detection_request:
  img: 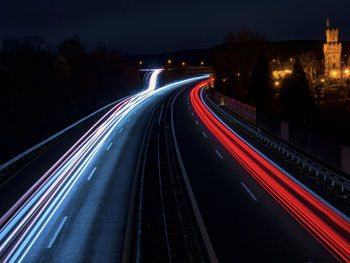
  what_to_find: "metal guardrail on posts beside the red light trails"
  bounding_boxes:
[205,93,350,196]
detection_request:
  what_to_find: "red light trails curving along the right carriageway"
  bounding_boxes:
[191,79,350,262]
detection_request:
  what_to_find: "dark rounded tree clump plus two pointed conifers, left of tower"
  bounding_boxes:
[212,30,315,127]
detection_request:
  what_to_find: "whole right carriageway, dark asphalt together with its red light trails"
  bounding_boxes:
[174,80,350,262]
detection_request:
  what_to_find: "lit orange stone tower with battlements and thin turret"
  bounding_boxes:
[323,19,342,79]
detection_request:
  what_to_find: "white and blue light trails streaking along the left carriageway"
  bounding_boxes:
[0,69,208,262]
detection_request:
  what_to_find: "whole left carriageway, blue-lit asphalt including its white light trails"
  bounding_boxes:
[0,70,205,262]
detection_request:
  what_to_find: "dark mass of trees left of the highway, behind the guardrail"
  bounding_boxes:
[0,38,141,163]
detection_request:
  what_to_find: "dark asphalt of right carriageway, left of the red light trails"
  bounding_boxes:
[174,81,349,262]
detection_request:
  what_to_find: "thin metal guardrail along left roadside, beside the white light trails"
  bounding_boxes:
[0,96,129,172]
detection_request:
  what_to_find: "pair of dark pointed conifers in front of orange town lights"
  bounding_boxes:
[247,55,316,125]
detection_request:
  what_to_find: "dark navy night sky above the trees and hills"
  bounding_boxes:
[0,0,350,54]
